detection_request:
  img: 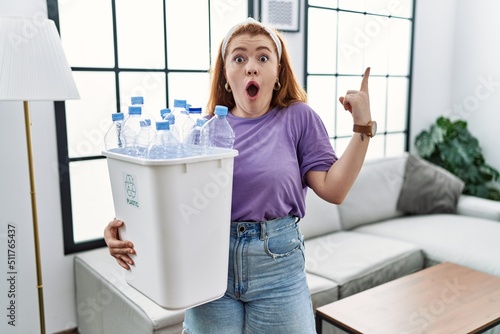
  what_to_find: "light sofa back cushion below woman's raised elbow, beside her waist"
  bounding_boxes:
[300,189,342,239]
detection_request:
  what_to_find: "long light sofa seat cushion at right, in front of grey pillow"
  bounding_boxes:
[356,214,500,276]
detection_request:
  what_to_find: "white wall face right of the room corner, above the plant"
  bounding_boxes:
[451,0,500,175]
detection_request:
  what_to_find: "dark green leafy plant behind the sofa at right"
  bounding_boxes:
[415,116,500,201]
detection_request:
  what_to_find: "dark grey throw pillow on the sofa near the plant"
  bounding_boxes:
[397,154,465,214]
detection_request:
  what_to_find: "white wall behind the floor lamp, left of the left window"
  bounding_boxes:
[0,0,76,334]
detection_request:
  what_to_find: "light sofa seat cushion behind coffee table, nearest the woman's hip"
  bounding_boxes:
[305,231,424,299]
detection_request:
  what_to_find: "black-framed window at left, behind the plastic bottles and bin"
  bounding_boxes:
[47,0,253,254]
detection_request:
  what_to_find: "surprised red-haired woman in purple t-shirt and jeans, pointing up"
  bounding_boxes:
[104,18,375,334]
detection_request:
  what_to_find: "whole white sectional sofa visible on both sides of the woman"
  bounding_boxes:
[74,154,500,334]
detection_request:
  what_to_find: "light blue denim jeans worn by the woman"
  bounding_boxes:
[183,216,316,334]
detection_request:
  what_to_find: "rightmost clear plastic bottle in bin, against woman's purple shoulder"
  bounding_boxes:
[201,106,235,148]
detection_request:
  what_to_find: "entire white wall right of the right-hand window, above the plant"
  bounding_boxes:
[411,0,500,177]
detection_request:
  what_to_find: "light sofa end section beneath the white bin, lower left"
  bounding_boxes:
[74,248,184,334]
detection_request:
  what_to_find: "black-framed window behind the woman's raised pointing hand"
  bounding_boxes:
[305,0,414,159]
